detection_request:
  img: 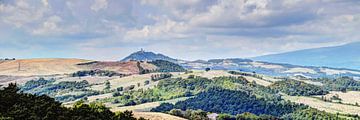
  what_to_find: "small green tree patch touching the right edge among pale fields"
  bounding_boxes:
[311,77,360,92]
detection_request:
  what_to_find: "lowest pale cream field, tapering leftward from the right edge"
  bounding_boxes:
[284,96,360,115]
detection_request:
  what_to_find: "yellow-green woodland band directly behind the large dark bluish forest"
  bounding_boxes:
[102,77,248,106]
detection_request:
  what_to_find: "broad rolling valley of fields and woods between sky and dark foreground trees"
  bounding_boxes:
[0,53,360,120]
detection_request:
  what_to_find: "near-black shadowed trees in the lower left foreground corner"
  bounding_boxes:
[0,84,143,120]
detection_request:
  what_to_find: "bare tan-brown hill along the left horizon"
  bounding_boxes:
[0,58,157,76]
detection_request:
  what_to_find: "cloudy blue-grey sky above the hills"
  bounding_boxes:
[0,0,360,60]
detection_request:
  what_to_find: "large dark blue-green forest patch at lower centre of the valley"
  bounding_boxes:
[153,88,306,116]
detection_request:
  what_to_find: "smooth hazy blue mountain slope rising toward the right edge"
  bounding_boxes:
[252,42,360,70]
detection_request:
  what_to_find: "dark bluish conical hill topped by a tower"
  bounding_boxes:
[121,50,179,63]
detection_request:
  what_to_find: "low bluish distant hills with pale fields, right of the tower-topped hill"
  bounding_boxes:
[181,58,360,78]
